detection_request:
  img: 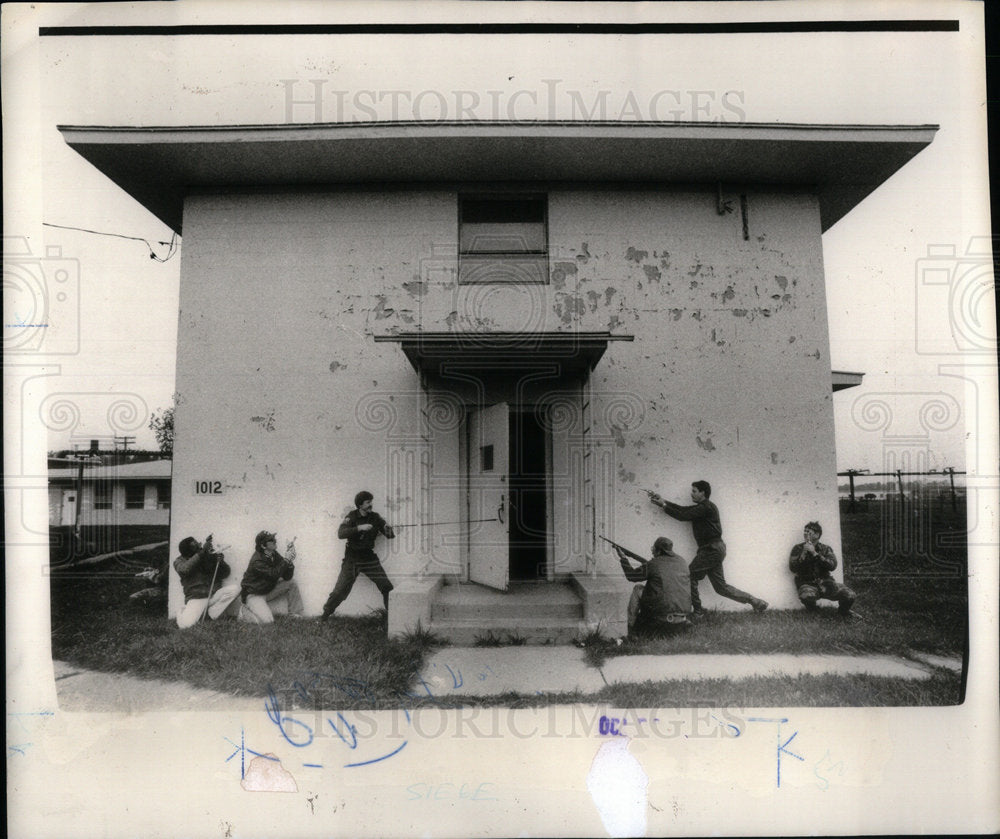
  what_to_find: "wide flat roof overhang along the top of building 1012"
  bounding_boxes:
[59,121,938,233]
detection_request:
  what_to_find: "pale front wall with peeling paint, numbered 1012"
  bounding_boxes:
[171,189,839,613]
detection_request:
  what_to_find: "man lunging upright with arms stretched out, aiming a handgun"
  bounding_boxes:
[649,481,767,617]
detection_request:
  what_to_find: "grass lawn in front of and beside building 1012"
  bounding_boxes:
[51,506,968,708]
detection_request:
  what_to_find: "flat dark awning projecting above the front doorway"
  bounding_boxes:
[375,332,635,375]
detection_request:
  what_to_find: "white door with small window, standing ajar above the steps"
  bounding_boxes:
[469,402,510,591]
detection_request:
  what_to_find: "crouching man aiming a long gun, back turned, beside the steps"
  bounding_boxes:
[615,536,691,635]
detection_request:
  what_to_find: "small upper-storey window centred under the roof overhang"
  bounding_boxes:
[458,196,548,283]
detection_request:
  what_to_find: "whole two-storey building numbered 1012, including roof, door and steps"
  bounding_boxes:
[61,122,936,637]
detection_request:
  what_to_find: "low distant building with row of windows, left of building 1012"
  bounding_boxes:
[48,460,173,527]
